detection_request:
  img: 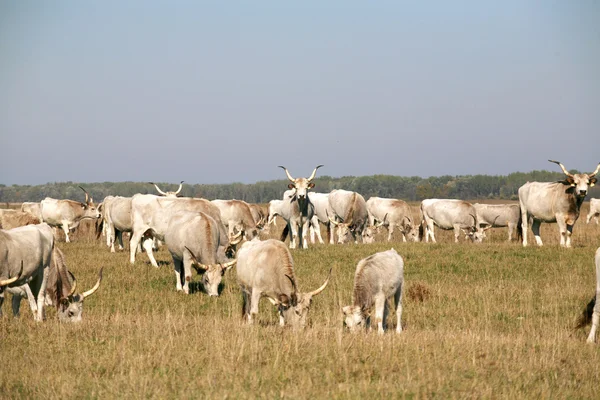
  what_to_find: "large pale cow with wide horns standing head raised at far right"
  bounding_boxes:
[519,160,600,247]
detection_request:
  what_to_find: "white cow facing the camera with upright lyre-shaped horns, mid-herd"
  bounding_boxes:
[279,165,322,249]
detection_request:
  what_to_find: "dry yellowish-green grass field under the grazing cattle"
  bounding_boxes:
[0,204,600,399]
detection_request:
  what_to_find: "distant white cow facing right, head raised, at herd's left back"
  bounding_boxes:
[41,186,100,243]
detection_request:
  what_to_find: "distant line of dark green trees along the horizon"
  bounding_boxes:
[0,171,600,203]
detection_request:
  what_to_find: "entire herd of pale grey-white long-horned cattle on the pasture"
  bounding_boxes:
[0,160,600,341]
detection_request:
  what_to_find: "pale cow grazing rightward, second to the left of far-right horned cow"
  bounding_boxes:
[421,199,485,243]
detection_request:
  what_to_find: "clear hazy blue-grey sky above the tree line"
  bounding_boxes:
[0,0,600,184]
